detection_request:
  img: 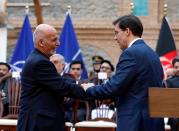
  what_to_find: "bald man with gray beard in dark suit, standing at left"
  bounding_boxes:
[17,24,85,131]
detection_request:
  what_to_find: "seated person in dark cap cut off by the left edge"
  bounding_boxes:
[0,62,11,116]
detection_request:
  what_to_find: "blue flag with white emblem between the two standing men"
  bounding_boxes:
[56,13,87,79]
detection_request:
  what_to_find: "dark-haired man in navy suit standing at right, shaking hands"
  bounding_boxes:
[83,15,164,131]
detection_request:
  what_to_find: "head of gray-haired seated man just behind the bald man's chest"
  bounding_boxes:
[50,54,65,75]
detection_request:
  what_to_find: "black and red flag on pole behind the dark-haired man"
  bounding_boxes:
[156,16,177,79]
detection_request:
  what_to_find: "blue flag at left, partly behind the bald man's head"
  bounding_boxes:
[10,15,34,72]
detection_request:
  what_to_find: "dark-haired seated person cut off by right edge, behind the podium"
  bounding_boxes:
[165,56,179,131]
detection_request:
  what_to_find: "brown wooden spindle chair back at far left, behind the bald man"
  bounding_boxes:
[3,77,21,119]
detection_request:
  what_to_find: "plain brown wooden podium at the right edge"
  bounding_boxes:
[149,87,179,129]
